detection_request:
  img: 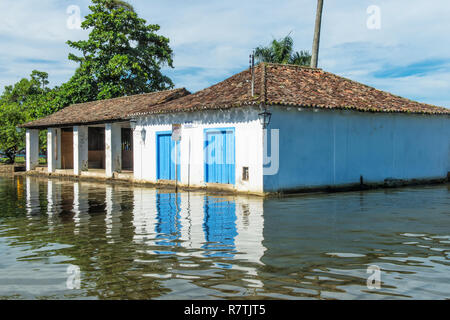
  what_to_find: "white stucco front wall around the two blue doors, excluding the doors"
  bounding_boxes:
[133,108,263,192]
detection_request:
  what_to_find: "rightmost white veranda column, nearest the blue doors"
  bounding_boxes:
[105,123,122,178]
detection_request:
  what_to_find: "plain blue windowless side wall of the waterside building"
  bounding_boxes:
[264,107,450,192]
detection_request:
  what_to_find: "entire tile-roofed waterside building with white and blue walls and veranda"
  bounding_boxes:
[24,64,450,194]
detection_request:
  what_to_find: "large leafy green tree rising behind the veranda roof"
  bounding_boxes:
[65,0,173,101]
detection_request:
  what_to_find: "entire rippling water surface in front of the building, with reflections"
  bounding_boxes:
[0,177,450,299]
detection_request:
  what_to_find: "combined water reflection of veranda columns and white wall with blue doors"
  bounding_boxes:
[26,177,265,263]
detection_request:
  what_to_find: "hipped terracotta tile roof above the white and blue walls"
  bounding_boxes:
[130,63,450,117]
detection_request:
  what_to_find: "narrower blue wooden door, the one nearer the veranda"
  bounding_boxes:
[156,131,180,180]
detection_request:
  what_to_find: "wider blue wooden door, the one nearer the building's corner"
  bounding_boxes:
[205,129,236,184]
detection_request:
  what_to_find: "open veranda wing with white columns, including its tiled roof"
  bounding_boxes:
[21,88,189,178]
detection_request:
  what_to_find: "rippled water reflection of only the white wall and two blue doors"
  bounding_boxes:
[133,188,265,263]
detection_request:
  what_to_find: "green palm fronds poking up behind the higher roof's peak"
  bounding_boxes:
[255,35,311,66]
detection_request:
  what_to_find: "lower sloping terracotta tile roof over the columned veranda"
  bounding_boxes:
[21,88,190,129]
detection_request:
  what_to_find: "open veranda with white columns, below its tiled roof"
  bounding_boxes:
[26,121,133,178]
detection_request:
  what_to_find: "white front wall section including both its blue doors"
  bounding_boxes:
[130,108,263,193]
